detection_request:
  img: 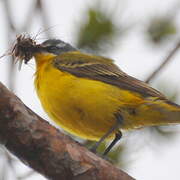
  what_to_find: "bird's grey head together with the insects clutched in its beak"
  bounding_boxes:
[12,35,77,68]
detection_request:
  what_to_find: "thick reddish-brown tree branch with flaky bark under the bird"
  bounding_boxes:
[0,83,133,180]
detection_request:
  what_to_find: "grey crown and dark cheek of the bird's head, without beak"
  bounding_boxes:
[41,39,77,55]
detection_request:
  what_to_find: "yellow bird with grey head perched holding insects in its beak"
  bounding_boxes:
[13,38,180,155]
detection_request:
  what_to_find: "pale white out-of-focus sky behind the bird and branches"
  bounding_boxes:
[0,0,180,180]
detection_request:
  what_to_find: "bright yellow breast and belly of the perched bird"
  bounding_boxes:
[35,61,142,140]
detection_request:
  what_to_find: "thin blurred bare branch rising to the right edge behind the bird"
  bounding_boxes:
[145,41,180,83]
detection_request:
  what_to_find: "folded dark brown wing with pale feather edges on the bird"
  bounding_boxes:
[53,51,166,99]
